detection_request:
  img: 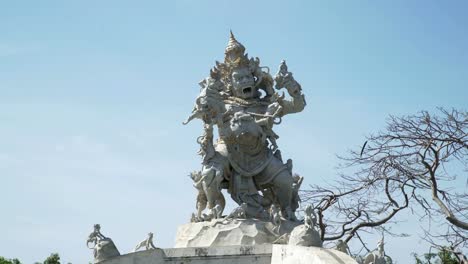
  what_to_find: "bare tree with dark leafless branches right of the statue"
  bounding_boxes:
[302,108,468,254]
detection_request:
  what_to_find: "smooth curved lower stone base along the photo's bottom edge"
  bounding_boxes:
[99,244,357,264]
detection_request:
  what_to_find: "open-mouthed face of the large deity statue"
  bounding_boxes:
[232,68,257,99]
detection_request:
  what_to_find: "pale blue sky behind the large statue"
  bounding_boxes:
[0,0,468,263]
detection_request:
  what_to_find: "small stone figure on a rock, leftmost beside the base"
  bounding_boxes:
[86,224,120,263]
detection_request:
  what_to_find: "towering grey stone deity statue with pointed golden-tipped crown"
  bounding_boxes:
[184,32,306,221]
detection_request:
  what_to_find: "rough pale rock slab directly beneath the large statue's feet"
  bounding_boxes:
[175,219,298,248]
